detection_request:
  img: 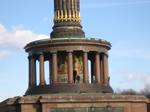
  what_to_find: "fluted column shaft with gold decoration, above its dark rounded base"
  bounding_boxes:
[54,0,80,22]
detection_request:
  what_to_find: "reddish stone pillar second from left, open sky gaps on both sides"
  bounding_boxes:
[39,54,45,85]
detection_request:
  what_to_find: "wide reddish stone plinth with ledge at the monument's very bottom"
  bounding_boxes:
[0,93,149,112]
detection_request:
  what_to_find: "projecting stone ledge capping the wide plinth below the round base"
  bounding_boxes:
[19,93,149,103]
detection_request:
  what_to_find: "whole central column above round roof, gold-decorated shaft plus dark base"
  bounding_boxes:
[50,0,85,38]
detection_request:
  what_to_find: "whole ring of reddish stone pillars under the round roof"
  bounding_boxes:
[28,52,109,87]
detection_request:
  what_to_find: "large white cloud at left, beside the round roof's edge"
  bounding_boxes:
[0,24,49,48]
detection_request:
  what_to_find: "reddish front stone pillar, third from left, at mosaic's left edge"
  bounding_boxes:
[52,52,58,83]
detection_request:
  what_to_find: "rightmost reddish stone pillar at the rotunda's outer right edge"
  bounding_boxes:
[103,54,109,85]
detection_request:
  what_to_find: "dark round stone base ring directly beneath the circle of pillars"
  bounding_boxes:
[25,83,113,95]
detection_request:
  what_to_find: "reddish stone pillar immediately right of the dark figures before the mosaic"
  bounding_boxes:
[83,52,89,83]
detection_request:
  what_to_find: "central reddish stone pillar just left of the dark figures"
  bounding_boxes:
[68,52,73,83]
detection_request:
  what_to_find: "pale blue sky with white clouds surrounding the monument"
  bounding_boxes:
[0,0,150,101]
